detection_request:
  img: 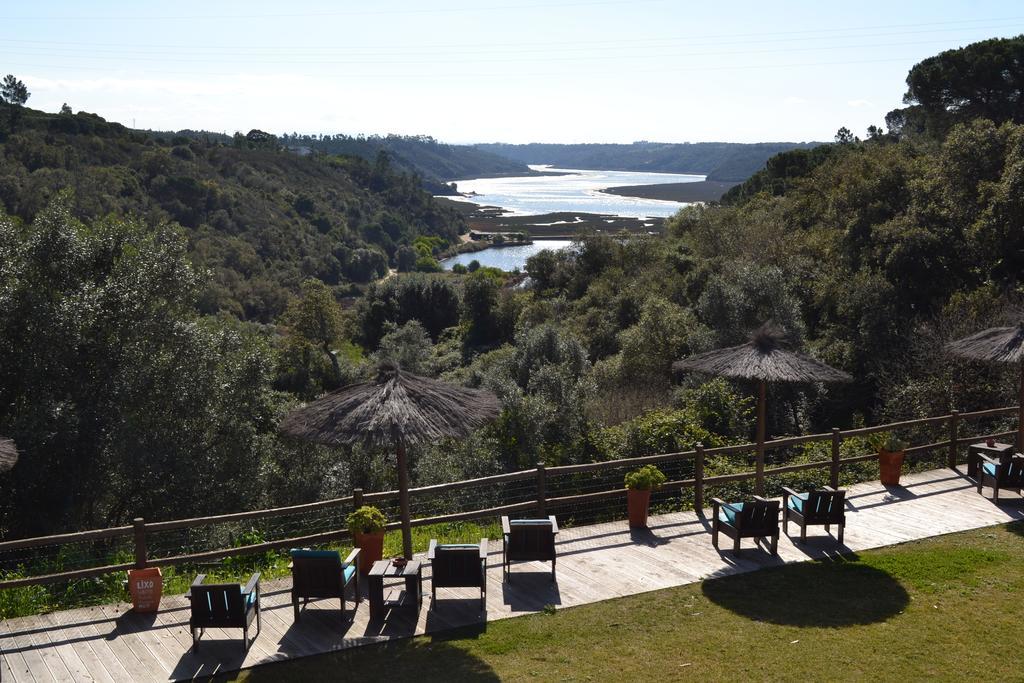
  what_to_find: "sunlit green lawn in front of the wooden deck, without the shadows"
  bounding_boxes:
[227,523,1024,683]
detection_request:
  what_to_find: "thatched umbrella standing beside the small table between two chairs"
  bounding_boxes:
[281,365,501,559]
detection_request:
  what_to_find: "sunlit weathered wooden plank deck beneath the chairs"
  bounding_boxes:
[0,469,1024,681]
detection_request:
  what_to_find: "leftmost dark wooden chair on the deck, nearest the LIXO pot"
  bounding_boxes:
[185,571,260,651]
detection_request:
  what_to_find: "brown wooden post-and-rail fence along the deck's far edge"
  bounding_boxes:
[0,407,1018,589]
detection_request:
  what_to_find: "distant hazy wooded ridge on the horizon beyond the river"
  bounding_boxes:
[476,142,818,181]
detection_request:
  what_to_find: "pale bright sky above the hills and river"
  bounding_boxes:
[0,0,1024,143]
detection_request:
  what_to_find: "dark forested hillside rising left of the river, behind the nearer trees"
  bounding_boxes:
[0,110,465,322]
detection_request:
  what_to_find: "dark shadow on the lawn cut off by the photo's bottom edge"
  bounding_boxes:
[220,625,501,683]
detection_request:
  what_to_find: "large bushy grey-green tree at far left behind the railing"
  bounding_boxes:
[0,196,278,536]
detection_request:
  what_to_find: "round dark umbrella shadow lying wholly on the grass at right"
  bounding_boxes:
[701,559,910,628]
